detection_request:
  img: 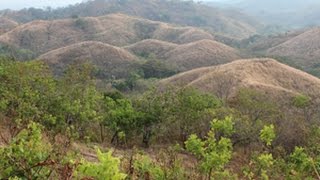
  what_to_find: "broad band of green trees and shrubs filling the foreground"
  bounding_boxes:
[0,59,320,179]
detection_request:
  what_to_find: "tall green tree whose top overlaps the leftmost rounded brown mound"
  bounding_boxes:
[52,64,103,138]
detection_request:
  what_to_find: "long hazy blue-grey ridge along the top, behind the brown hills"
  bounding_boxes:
[0,0,261,39]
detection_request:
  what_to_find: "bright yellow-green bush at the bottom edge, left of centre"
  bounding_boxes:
[76,149,126,180]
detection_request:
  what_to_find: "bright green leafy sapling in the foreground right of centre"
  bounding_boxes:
[185,117,233,177]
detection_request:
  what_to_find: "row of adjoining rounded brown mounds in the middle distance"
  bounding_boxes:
[38,39,240,79]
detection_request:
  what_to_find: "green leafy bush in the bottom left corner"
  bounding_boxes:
[0,123,52,179]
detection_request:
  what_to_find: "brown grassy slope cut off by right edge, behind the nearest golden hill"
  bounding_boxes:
[268,28,320,65]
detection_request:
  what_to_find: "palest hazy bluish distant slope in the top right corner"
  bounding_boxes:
[210,0,320,28]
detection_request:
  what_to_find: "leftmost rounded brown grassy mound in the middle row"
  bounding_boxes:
[38,41,137,78]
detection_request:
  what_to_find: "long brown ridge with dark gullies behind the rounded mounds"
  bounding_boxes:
[0,14,213,54]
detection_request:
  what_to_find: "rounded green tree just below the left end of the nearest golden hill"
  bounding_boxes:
[165,88,221,142]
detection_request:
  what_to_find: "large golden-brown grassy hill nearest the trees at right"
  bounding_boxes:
[161,58,320,98]
